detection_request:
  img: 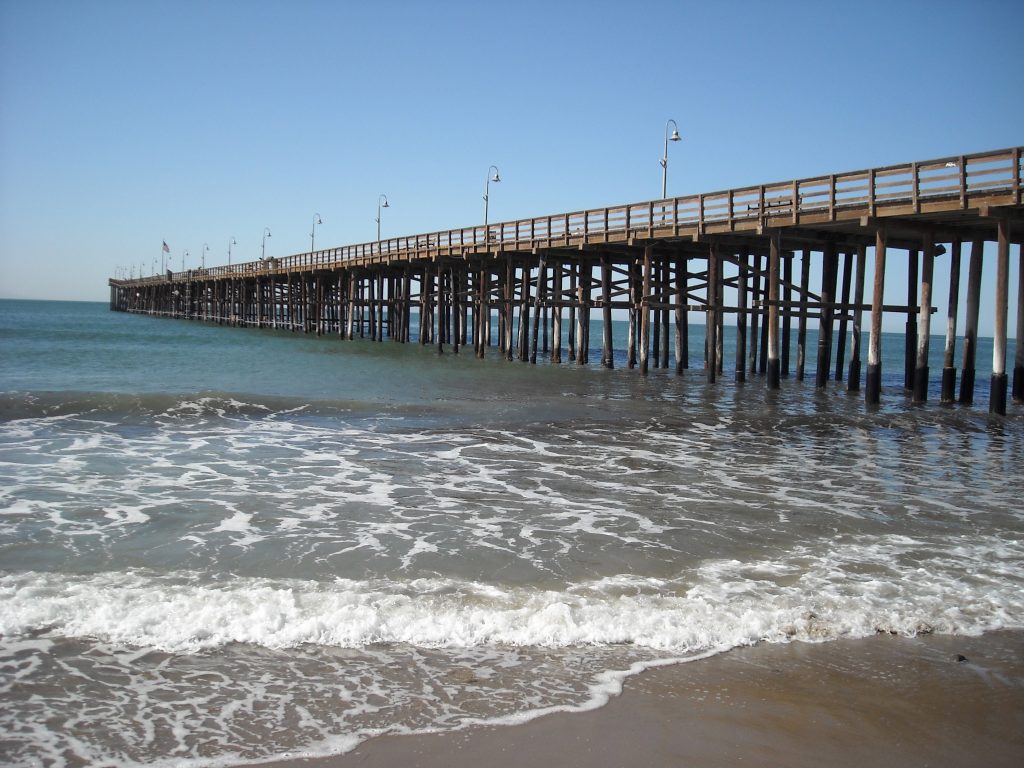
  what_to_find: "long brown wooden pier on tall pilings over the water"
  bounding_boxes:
[110,146,1024,414]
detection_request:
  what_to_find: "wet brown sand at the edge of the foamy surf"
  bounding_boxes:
[274,632,1024,768]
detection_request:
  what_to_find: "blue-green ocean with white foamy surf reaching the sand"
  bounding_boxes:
[0,301,1024,768]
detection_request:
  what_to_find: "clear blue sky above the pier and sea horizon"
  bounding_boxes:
[0,0,1024,335]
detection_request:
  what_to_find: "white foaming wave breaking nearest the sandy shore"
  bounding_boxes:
[0,539,1024,654]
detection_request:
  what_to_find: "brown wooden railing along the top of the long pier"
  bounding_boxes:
[123,146,1024,283]
